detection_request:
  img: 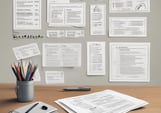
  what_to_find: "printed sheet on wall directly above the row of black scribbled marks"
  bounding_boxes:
[13,0,41,30]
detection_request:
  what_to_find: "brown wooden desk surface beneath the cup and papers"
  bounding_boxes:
[0,84,161,113]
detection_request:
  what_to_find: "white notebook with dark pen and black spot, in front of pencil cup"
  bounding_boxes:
[9,101,58,113]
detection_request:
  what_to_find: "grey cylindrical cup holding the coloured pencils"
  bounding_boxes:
[16,80,34,102]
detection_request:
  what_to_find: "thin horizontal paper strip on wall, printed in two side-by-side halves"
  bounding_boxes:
[47,30,85,38]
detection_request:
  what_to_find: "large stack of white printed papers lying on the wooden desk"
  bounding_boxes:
[55,90,148,113]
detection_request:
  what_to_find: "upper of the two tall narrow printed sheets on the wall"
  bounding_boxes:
[90,4,106,35]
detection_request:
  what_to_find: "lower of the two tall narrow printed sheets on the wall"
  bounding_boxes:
[87,42,105,75]
